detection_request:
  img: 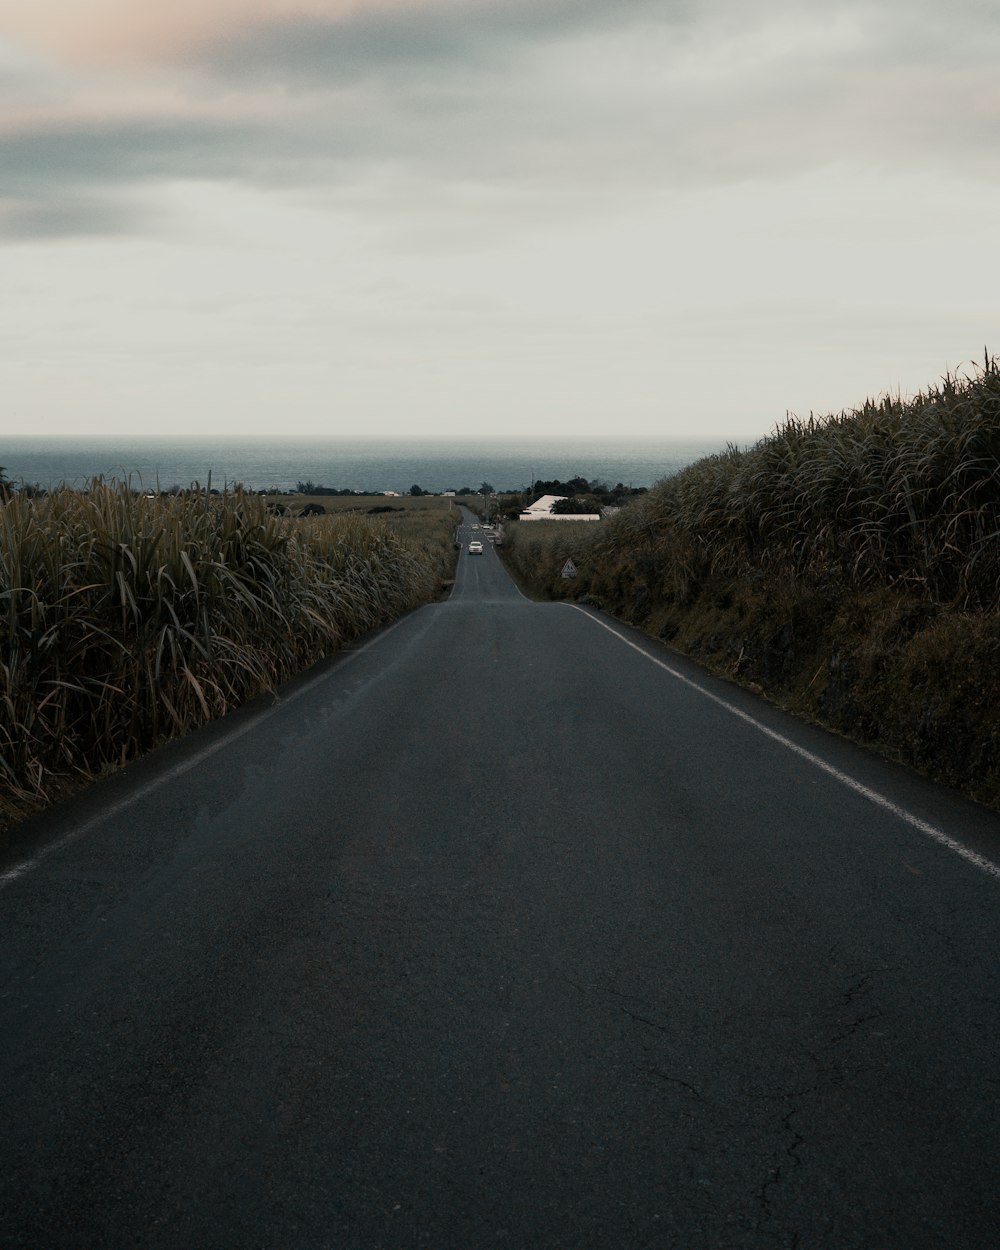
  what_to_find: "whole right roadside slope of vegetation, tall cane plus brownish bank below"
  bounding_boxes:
[503,358,1000,806]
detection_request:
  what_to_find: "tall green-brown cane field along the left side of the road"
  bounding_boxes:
[0,481,454,818]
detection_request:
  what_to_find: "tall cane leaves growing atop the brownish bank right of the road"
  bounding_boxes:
[585,358,1000,611]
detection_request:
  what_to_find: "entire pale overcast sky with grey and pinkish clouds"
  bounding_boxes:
[0,0,1000,439]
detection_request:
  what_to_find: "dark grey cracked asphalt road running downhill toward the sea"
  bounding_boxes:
[0,512,1000,1250]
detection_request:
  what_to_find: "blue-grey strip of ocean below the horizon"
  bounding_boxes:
[0,435,740,494]
